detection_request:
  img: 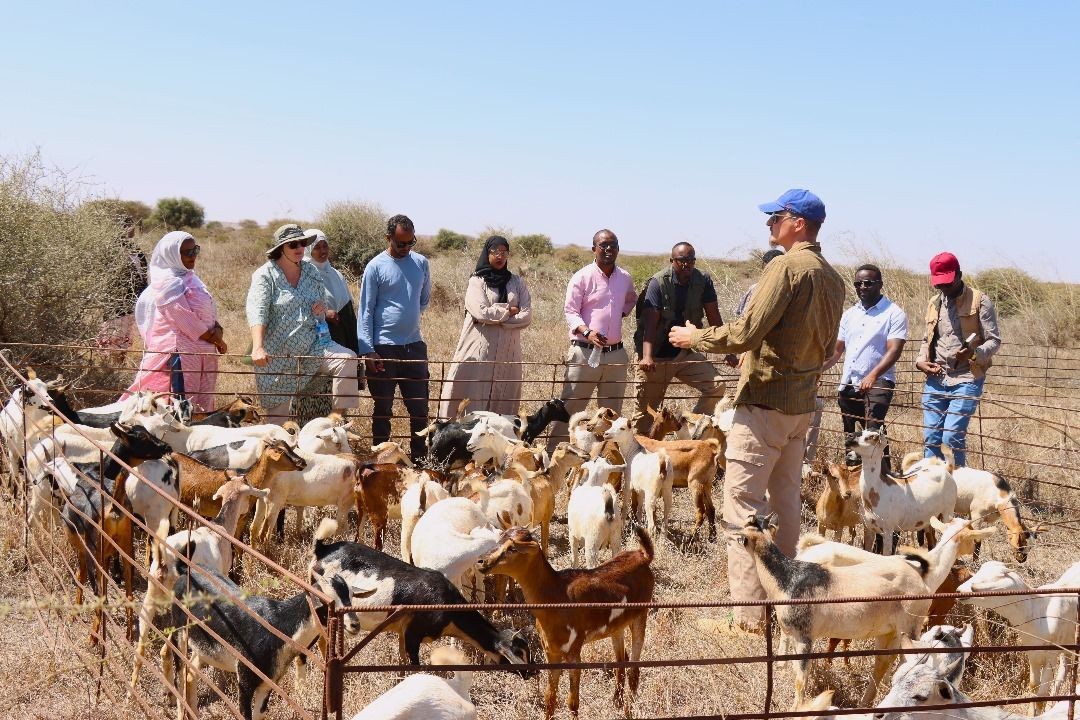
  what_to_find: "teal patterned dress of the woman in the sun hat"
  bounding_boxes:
[246,260,330,408]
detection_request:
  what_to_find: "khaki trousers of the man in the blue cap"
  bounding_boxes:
[724,405,812,626]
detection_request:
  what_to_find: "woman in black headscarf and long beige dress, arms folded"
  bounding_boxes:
[438,235,532,418]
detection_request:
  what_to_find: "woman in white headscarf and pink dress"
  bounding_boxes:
[124,231,228,411]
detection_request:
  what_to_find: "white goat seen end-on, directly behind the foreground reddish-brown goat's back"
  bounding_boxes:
[566,458,626,568]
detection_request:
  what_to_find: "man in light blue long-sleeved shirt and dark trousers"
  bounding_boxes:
[356,215,431,460]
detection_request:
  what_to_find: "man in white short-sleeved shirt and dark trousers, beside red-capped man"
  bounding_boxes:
[822,264,907,470]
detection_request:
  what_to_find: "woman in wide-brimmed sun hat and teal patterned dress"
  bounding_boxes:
[246,223,360,424]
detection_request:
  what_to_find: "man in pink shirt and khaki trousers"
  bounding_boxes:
[551,230,637,446]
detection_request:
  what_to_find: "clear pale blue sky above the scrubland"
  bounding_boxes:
[0,2,1080,282]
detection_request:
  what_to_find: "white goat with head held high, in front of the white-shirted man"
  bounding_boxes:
[852,430,956,555]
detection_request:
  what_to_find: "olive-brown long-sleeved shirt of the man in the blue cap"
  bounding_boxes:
[691,242,845,415]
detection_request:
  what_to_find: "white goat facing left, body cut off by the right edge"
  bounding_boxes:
[957,560,1080,711]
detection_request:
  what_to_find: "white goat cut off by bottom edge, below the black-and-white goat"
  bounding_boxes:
[352,647,476,720]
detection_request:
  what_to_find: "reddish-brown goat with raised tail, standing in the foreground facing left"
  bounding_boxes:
[477,526,656,720]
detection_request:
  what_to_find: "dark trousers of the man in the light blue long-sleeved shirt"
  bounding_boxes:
[367,340,430,460]
